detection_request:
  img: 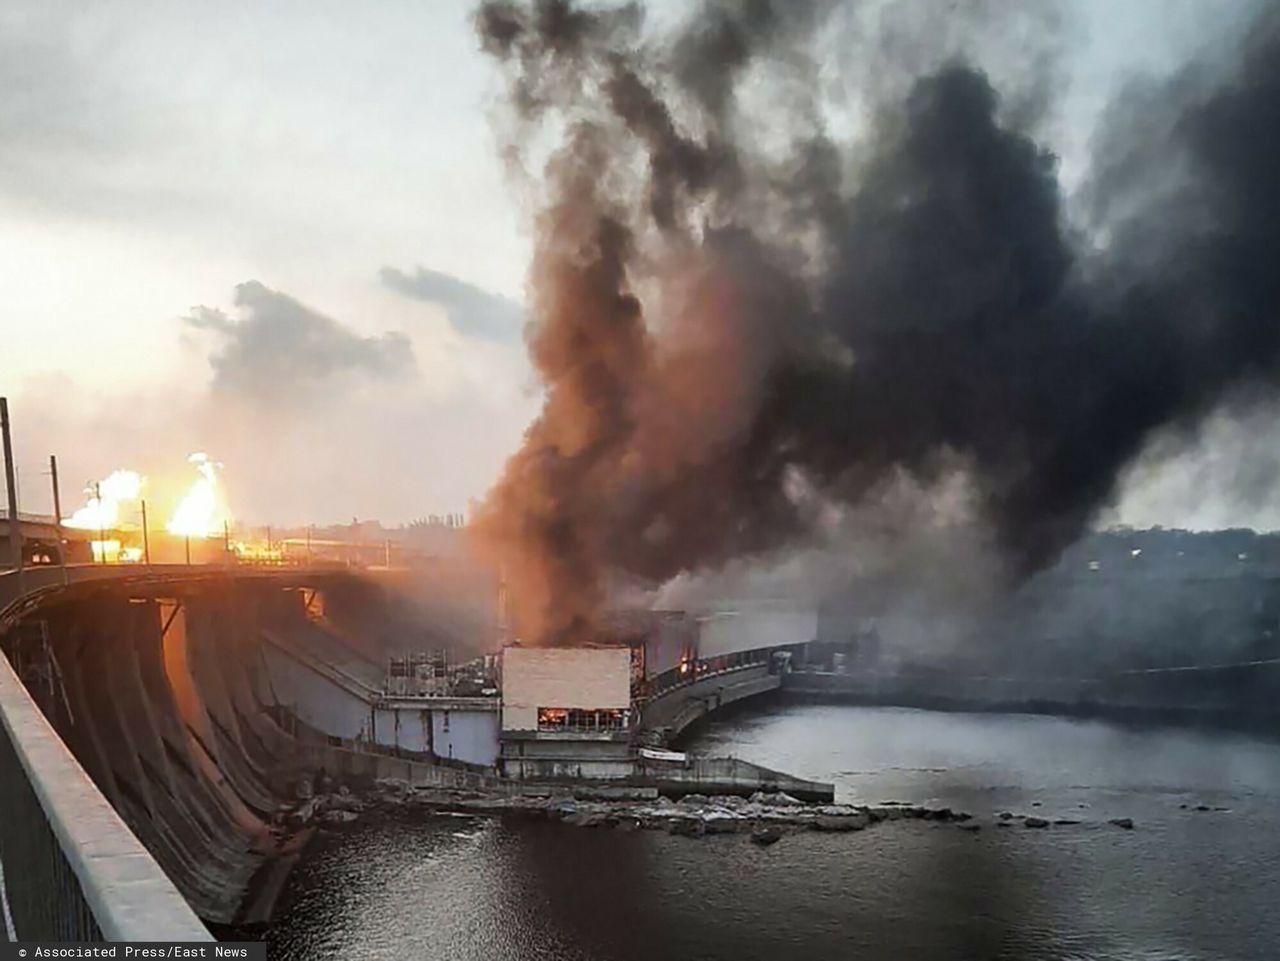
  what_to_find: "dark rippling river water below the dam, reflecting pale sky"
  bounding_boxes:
[269,705,1280,961]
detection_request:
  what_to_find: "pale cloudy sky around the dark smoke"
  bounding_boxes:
[0,0,1275,526]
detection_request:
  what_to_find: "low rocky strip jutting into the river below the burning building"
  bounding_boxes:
[285,779,1134,845]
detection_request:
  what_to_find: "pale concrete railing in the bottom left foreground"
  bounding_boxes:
[0,655,212,942]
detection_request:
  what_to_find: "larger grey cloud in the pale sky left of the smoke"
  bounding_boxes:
[184,280,416,401]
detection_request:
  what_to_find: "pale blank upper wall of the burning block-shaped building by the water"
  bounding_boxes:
[502,647,631,731]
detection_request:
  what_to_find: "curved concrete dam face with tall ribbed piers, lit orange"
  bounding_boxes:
[6,573,440,924]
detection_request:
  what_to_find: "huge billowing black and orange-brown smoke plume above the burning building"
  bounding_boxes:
[476,0,1280,642]
